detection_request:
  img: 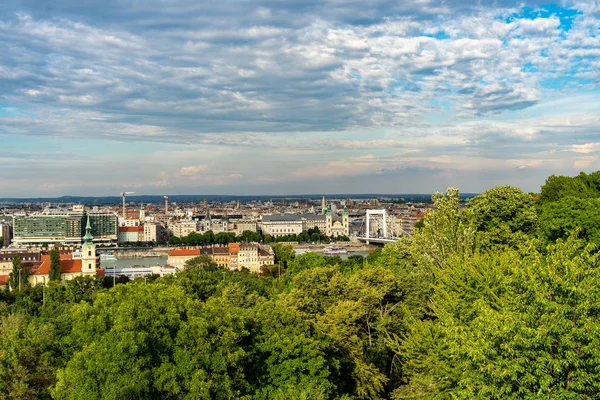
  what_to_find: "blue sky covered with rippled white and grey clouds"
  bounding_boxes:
[0,0,600,197]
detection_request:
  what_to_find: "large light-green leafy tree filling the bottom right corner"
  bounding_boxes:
[395,238,600,399]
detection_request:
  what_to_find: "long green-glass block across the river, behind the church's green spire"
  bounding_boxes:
[13,212,118,246]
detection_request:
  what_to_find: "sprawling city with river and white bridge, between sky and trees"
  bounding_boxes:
[0,193,432,288]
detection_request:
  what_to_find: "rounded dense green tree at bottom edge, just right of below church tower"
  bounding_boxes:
[52,284,193,399]
